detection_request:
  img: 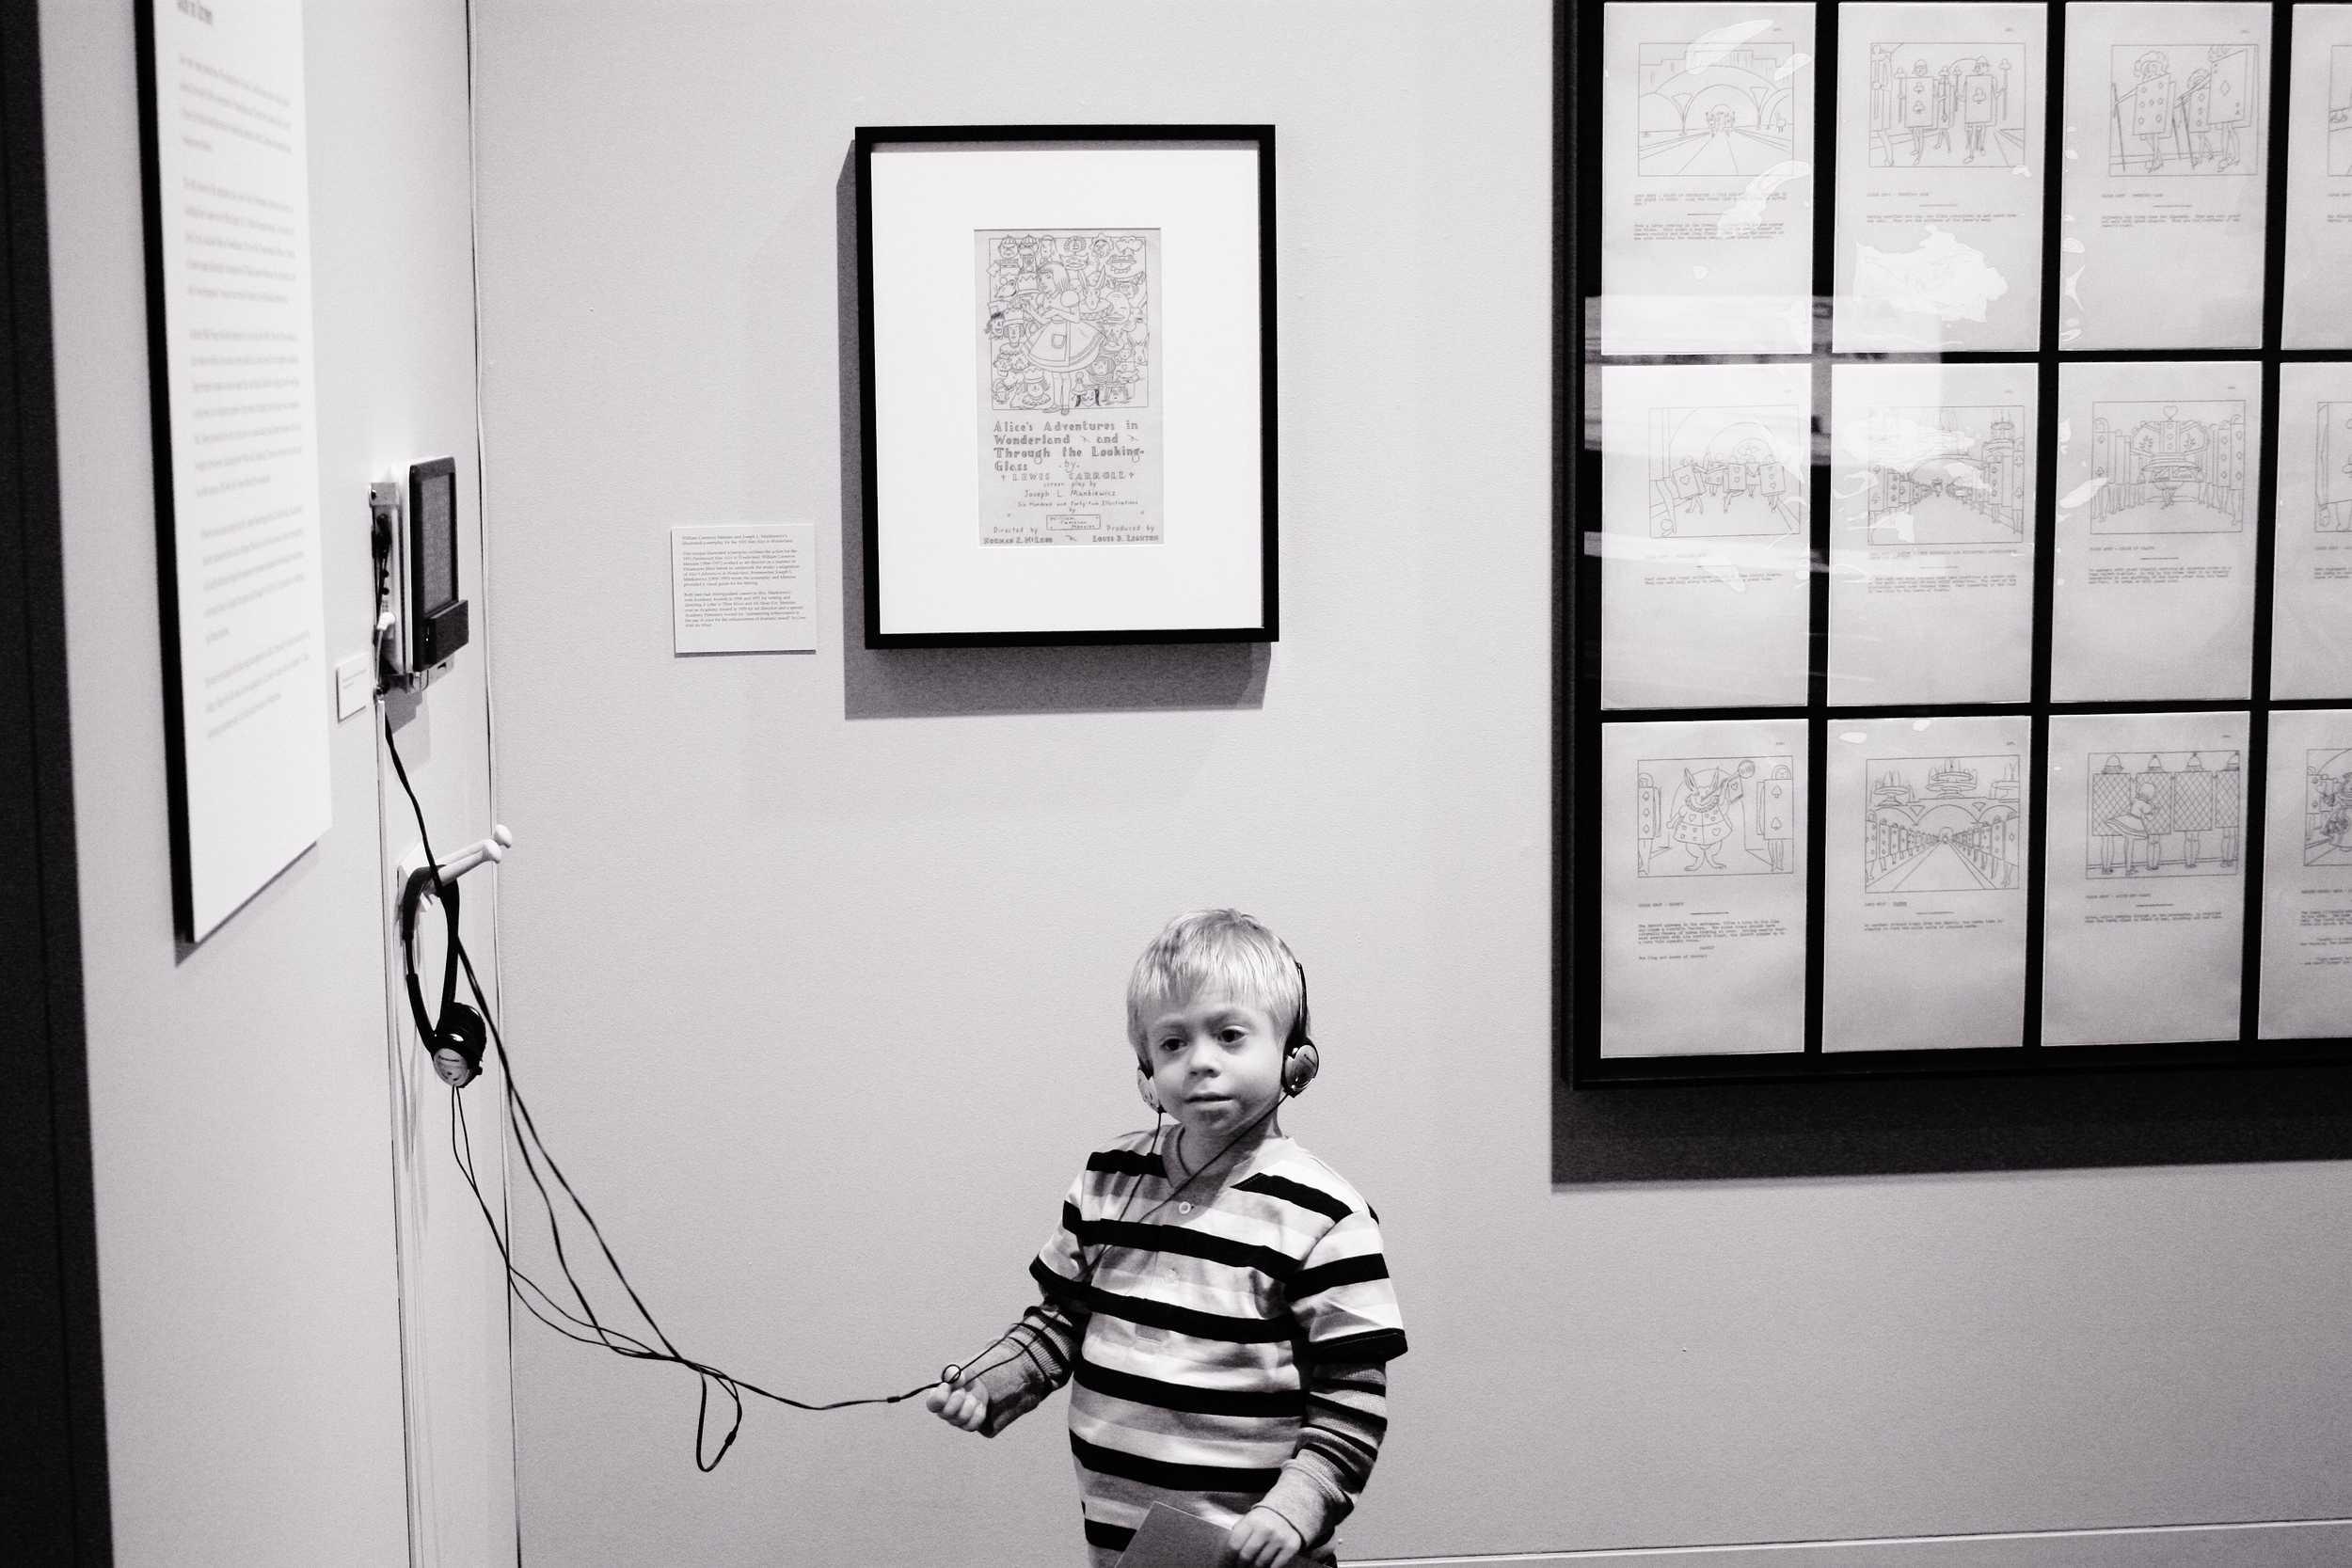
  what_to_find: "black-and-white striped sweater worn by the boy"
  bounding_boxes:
[969,1131,1405,1568]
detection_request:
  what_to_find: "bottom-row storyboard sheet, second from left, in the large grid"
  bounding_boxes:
[1820,715,2032,1051]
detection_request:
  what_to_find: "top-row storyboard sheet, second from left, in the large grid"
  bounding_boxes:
[1835,5,2049,353]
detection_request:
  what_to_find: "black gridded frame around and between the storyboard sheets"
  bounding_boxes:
[1552,0,2352,1091]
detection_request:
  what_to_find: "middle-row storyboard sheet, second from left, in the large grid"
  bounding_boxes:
[1830,364,2037,705]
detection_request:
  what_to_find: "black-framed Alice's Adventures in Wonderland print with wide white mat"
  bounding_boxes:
[856,124,1279,649]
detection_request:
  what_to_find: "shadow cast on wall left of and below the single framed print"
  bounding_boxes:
[833,146,1273,720]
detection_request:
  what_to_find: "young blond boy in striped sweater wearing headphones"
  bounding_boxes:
[925,910,1405,1568]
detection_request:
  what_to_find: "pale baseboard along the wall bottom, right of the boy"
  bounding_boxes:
[1341,1519,2352,1568]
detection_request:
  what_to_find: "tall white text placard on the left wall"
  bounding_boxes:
[139,0,332,942]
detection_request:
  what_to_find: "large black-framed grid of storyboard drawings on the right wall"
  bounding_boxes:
[1560,0,2352,1086]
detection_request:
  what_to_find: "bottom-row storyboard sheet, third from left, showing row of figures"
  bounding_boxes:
[2042,712,2247,1046]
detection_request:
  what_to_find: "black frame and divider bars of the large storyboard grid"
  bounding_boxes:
[1552,0,2352,1104]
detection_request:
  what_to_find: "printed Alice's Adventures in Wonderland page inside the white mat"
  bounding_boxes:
[974,228,1162,546]
